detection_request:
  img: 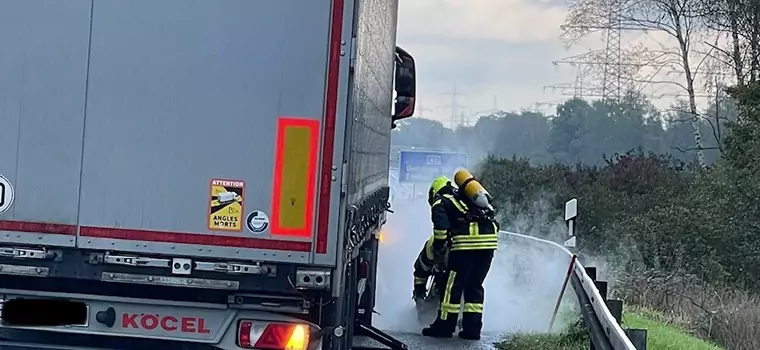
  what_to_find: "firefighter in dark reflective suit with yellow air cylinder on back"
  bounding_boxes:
[422,172,499,340]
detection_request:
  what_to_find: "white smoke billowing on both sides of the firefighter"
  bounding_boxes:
[374,187,572,333]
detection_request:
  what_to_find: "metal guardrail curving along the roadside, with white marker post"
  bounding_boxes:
[500,199,646,350]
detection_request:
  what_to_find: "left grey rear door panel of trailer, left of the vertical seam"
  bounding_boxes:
[0,0,91,246]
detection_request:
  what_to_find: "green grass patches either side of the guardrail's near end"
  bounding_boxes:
[495,308,722,350]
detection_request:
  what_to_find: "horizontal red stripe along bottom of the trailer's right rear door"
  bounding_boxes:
[79,226,311,252]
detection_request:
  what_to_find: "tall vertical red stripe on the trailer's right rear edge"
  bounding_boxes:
[316,0,344,254]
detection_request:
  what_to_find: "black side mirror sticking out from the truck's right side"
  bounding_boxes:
[391,47,417,128]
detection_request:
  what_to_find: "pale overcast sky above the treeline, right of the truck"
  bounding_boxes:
[397,0,720,125]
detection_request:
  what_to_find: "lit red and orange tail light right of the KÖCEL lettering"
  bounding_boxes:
[238,320,310,350]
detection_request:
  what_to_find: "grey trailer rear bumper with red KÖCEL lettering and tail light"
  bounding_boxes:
[0,286,321,350]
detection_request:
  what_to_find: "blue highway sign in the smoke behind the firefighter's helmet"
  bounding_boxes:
[398,151,467,183]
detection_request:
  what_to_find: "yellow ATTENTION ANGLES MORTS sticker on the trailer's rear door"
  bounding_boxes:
[208,179,245,231]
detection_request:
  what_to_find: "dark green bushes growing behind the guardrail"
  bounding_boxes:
[479,149,760,289]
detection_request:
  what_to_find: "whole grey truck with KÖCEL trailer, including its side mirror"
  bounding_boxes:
[0,0,415,350]
